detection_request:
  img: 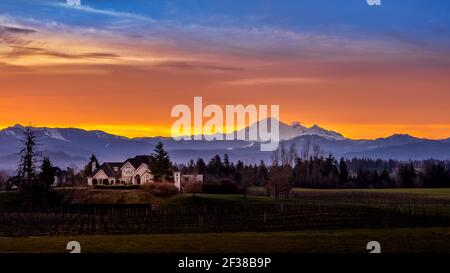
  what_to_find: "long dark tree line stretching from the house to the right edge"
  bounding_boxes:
[178,142,450,197]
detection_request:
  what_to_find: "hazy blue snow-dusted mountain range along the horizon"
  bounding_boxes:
[0,122,450,171]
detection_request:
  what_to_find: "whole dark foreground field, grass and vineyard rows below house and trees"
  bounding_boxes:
[0,188,450,253]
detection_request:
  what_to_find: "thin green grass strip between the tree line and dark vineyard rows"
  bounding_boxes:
[0,187,450,207]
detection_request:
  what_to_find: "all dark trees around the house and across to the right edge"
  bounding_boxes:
[0,128,450,198]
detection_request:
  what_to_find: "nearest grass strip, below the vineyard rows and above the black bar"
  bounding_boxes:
[0,228,450,253]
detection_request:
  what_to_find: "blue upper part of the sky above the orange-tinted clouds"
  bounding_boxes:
[0,0,450,56]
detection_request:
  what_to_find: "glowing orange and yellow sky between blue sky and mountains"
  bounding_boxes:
[0,8,450,139]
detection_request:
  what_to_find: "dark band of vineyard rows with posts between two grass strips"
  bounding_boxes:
[0,203,450,236]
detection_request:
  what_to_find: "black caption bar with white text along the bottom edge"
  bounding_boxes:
[0,253,450,273]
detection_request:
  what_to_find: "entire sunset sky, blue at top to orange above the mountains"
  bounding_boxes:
[0,0,450,139]
